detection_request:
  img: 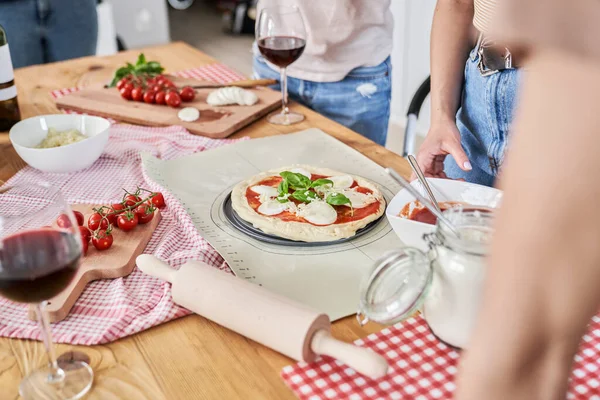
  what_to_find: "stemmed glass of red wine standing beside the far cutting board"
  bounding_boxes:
[256,6,306,125]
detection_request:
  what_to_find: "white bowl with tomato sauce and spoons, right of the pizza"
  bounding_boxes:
[386,178,502,251]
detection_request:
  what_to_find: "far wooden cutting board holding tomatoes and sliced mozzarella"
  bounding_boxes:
[56,77,281,139]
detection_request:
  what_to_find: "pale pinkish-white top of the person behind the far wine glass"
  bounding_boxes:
[255,0,394,82]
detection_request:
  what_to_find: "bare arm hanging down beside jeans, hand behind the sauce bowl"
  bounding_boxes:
[417,0,473,177]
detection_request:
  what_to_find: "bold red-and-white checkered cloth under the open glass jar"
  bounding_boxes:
[281,316,600,400]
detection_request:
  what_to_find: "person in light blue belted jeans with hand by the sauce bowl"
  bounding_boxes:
[417,0,520,186]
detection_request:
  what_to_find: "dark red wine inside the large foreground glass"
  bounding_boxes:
[0,229,81,303]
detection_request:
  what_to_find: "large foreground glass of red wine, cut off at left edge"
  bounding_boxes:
[0,184,94,399]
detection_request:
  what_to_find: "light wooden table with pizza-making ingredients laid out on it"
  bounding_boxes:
[0,43,410,400]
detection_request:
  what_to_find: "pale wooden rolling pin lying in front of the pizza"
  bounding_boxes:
[136,254,388,379]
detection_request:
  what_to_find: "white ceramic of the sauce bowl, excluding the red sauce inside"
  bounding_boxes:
[385,178,502,251]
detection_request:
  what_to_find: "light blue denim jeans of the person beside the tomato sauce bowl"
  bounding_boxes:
[444,50,520,186]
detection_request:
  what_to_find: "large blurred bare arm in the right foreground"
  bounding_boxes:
[456,43,600,400]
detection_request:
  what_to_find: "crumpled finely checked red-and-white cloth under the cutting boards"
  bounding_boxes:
[0,64,243,345]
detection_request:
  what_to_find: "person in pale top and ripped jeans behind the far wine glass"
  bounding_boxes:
[254,0,394,145]
